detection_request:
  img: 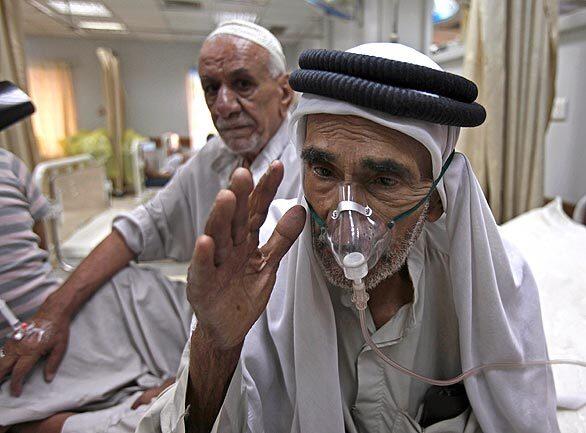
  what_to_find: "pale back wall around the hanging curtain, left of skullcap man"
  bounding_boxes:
[25,36,299,136]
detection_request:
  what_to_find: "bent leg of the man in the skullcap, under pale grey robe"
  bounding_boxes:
[0,265,191,425]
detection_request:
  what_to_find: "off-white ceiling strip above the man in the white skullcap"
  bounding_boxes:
[22,0,323,43]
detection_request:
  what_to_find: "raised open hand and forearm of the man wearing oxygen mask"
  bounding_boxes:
[186,162,305,433]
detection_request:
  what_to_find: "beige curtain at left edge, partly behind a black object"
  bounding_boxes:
[0,0,39,169]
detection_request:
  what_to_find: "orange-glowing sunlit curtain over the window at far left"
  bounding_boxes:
[27,63,77,158]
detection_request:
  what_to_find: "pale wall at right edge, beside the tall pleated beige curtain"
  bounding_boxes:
[440,26,586,204]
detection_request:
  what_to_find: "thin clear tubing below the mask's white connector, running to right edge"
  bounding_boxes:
[352,279,586,386]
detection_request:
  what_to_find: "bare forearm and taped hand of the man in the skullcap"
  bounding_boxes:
[0,230,134,396]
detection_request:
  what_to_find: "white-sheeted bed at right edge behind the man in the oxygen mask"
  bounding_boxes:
[500,197,586,433]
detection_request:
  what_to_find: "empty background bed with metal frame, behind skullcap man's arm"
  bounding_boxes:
[33,152,188,280]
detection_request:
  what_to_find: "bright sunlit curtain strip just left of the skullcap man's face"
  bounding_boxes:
[187,68,218,151]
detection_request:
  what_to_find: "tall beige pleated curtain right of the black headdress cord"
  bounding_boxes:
[459,0,558,223]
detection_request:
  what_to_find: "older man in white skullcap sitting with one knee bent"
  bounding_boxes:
[0,20,300,433]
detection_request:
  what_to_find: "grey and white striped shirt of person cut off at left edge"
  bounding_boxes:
[0,149,60,345]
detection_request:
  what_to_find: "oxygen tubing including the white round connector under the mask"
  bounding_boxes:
[343,252,586,386]
